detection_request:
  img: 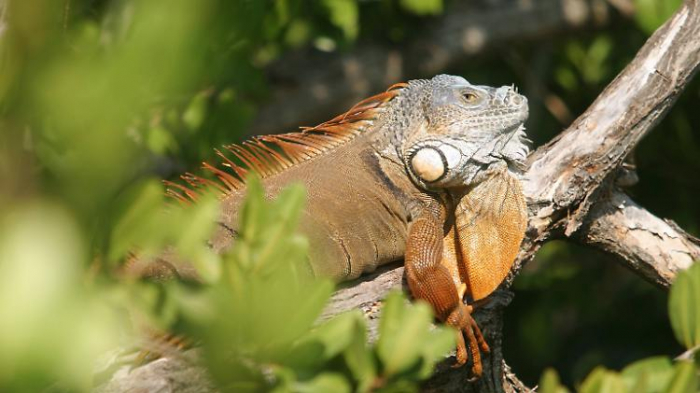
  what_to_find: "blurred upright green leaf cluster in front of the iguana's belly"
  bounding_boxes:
[181,177,334,380]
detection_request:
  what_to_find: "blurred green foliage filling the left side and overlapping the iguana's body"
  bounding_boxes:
[0,0,460,392]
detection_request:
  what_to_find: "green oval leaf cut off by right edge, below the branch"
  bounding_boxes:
[668,263,700,349]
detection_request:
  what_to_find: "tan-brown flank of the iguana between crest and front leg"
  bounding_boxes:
[212,129,421,281]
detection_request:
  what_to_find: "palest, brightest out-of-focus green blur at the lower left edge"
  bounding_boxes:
[0,204,127,392]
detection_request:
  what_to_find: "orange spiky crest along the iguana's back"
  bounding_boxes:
[164,83,408,204]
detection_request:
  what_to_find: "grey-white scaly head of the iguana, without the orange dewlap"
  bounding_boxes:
[397,75,528,189]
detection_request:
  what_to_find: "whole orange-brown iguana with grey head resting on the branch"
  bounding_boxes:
[134,75,528,376]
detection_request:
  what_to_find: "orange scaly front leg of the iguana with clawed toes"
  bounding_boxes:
[405,201,489,377]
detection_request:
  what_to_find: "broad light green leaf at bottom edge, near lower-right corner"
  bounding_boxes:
[620,356,673,393]
